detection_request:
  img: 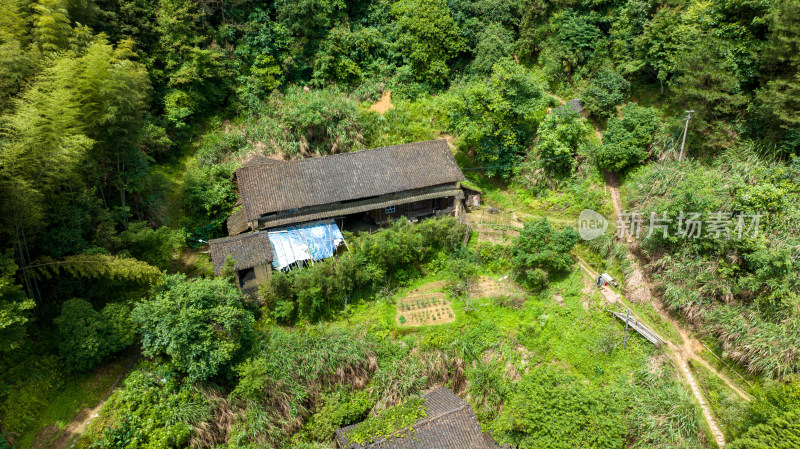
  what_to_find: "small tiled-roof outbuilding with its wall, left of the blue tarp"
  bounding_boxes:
[208,232,273,293]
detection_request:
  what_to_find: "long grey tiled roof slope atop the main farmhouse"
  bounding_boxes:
[236,140,464,221]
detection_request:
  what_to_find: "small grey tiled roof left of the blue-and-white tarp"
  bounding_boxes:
[208,232,272,275]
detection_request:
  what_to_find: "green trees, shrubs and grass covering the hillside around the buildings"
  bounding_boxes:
[0,0,800,449]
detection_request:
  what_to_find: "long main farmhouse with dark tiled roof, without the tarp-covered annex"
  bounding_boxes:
[228,139,464,235]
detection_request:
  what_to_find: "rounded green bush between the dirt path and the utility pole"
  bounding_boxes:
[590,103,660,171]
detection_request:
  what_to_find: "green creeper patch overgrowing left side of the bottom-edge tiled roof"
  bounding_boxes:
[347,398,428,444]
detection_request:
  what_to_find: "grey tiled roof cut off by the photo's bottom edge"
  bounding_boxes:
[336,387,498,449]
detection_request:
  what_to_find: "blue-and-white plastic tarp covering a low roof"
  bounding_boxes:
[268,219,344,270]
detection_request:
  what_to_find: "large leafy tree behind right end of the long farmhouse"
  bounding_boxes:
[450,61,546,177]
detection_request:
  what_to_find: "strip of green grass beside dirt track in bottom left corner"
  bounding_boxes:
[17,355,128,448]
